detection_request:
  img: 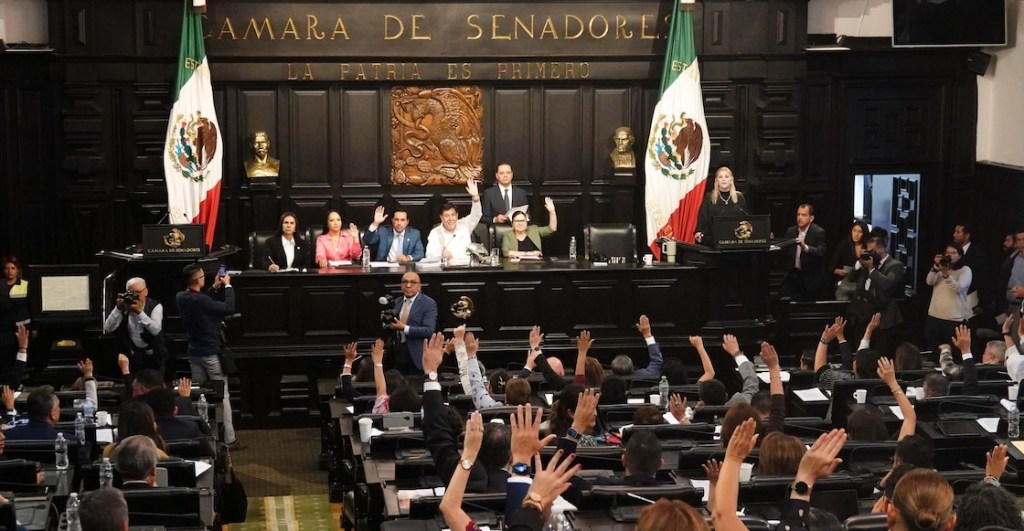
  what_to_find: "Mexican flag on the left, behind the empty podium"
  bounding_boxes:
[164,0,223,247]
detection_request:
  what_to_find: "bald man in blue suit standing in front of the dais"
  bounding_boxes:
[391,271,437,374]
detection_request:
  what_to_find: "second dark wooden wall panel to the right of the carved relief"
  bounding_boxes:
[539,88,592,184]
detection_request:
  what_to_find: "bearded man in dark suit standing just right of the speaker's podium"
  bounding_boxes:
[782,204,825,301]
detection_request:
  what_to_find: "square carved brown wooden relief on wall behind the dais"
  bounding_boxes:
[391,87,483,186]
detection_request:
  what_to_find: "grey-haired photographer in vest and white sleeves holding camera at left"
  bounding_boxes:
[103,276,167,378]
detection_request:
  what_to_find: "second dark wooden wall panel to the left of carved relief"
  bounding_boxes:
[289,89,329,189]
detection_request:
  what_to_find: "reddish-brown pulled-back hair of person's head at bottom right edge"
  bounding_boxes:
[886,469,956,531]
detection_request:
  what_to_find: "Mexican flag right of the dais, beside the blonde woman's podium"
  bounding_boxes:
[644,4,711,256]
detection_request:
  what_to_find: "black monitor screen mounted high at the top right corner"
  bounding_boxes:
[892,0,1007,47]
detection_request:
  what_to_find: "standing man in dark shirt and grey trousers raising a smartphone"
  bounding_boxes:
[175,264,244,450]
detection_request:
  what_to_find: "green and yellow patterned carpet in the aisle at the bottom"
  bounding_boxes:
[228,494,340,531]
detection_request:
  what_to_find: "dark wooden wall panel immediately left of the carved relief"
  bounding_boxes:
[342,90,382,188]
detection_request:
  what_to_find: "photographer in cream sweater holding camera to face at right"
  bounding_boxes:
[925,242,973,351]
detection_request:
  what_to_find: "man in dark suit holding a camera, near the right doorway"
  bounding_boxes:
[847,236,906,355]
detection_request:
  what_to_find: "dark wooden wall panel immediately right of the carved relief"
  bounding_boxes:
[491,87,544,184]
